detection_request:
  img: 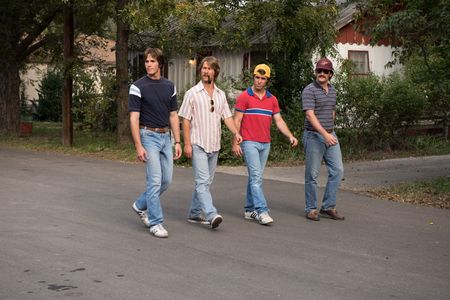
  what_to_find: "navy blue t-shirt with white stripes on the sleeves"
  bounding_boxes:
[128,75,178,128]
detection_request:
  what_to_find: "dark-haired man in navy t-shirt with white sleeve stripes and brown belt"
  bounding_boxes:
[128,48,182,238]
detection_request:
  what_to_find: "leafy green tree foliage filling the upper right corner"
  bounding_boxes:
[358,0,450,137]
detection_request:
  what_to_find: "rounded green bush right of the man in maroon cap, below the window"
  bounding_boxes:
[335,67,427,150]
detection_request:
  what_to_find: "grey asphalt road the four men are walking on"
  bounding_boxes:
[0,148,450,300]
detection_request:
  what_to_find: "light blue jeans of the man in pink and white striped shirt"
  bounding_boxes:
[188,145,219,221]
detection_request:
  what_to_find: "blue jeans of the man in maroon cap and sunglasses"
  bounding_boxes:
[303,130,344,213]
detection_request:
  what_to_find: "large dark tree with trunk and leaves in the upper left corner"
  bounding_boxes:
[0,0,110,134]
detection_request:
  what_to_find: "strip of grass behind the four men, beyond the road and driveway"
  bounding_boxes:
[0,122,450,166]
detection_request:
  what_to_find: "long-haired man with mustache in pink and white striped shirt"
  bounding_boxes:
[178,56,242,229]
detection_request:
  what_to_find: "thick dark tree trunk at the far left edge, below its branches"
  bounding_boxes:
[0,59,20,135]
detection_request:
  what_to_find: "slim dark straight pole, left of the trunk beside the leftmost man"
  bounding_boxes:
[62,0,73,147]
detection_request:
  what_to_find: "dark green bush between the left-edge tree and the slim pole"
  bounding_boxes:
[36,69,64,122]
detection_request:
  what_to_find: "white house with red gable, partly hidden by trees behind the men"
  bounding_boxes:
[161,4,401,90]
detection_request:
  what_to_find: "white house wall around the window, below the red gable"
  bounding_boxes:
[331,43,402,76]
